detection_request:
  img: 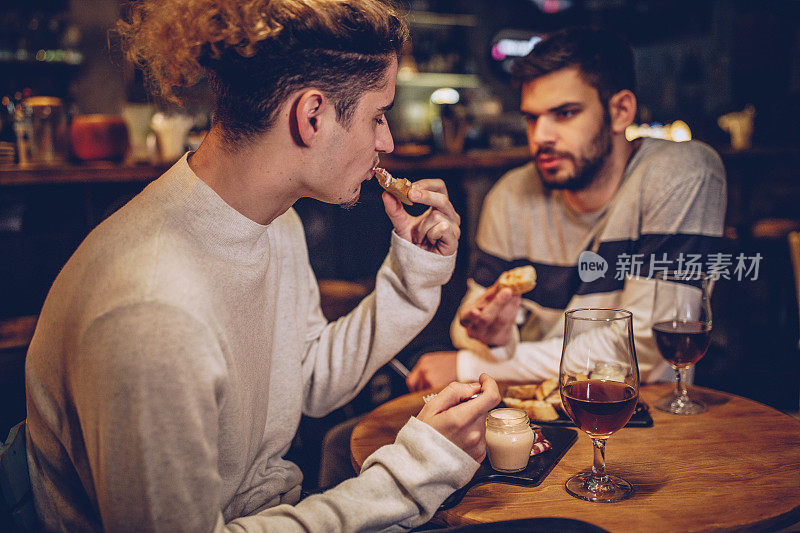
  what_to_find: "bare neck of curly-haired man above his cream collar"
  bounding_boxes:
[189,126,301,225]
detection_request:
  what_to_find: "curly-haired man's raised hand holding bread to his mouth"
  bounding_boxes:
[382,179,461,255]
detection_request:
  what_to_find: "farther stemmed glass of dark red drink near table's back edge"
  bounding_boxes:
[653,271,711,415]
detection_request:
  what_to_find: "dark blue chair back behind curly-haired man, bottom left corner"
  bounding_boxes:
[0,421,38,531]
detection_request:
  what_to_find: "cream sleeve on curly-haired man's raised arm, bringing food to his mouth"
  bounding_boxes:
[303,232,455,416]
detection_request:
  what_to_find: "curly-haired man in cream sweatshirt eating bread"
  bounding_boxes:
[26,0,499,532]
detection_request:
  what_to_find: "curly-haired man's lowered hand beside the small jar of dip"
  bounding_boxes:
[417,374,500,463]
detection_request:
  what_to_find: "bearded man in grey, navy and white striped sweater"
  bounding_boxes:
[407,28,726,390]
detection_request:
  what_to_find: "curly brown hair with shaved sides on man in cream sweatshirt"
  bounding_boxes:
[116,0,408,143]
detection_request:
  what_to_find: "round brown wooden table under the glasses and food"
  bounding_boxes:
[351,384,800,532]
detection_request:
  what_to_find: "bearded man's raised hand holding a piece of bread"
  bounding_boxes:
[459,285,522,346]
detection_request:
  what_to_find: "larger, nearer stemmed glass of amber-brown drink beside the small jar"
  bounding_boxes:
[559,309,639,502]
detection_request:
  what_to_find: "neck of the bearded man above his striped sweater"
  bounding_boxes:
[562,136,640,213]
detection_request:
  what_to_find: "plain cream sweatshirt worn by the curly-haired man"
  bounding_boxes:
[26,156,478,532]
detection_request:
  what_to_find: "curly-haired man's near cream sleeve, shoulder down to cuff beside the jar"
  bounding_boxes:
[69,303,478,532]
